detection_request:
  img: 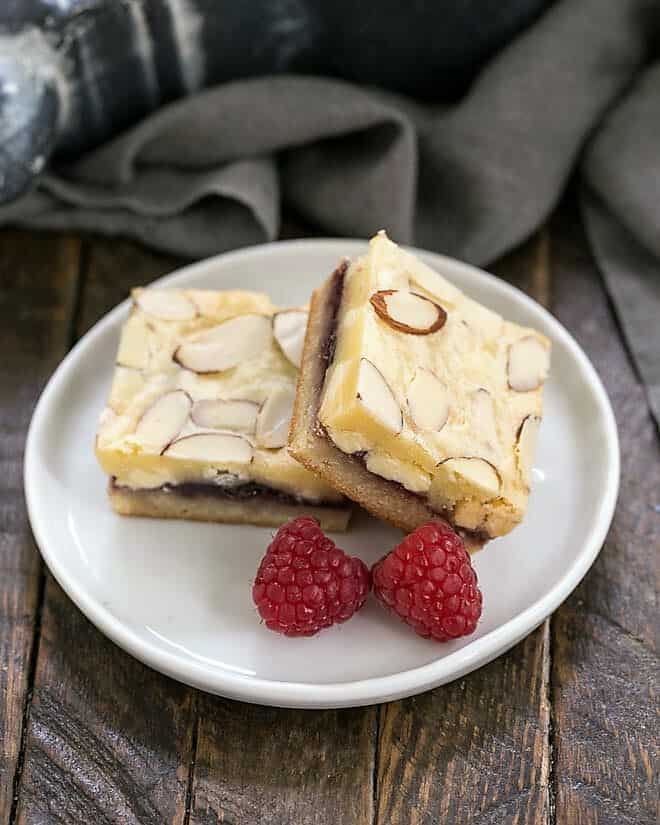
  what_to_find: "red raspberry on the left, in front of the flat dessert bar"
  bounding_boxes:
[252,516,371,636]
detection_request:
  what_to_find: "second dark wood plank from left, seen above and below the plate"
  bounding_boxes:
[17,233,196,825]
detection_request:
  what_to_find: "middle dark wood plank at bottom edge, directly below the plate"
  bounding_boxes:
[190,697,377,825]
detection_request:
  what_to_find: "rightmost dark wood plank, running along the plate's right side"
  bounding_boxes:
[552,206,660,825]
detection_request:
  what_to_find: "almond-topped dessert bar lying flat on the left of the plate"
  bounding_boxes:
[96,289,350,530]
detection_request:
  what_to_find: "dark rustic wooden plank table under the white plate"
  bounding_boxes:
[0,207,660,825]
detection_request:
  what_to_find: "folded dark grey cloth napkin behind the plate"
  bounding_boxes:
[0,0,660,423]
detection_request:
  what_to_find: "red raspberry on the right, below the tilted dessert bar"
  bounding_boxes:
[371,521,482,642]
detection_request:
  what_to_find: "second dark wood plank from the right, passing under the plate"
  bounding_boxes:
[376,230,551,825]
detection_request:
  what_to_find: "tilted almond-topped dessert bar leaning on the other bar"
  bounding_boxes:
[289,233,550,549]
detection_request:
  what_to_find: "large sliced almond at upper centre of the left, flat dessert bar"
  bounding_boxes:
[173,314,273,373]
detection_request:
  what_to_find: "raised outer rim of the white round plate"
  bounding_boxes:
[23,238,620,709]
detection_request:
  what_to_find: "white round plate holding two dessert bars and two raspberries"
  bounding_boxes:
[25,240,619,708]
